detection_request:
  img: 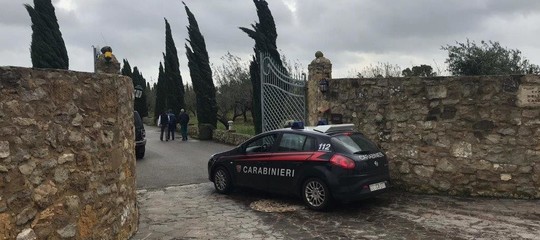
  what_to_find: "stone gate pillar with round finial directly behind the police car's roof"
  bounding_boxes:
[306,51,332,126]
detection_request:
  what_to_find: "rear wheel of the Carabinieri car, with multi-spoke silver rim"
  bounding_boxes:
[302,178,332,211]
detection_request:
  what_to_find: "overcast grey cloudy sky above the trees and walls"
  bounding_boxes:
[0,0,540,82]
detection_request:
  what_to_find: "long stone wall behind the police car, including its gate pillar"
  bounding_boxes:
[308,54,540,198]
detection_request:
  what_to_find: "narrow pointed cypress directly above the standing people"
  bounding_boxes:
[164,19,185,114]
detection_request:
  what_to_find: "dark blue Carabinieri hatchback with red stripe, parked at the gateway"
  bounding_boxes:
[208,122,390,210]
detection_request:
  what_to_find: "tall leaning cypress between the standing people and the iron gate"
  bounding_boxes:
[182,2,217,127]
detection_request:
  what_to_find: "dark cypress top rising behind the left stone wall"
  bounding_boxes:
[24,0,69,69]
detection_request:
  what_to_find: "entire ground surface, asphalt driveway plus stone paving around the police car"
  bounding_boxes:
[132,127,540,240]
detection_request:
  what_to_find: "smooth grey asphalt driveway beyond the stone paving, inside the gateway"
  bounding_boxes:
[137,125,233,189]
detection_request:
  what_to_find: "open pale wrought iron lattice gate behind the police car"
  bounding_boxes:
[260,53,306,132]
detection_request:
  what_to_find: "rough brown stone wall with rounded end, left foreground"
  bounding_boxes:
[0,67,138,239]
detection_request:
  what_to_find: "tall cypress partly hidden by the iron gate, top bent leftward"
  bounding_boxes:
[240,0,286,133]
